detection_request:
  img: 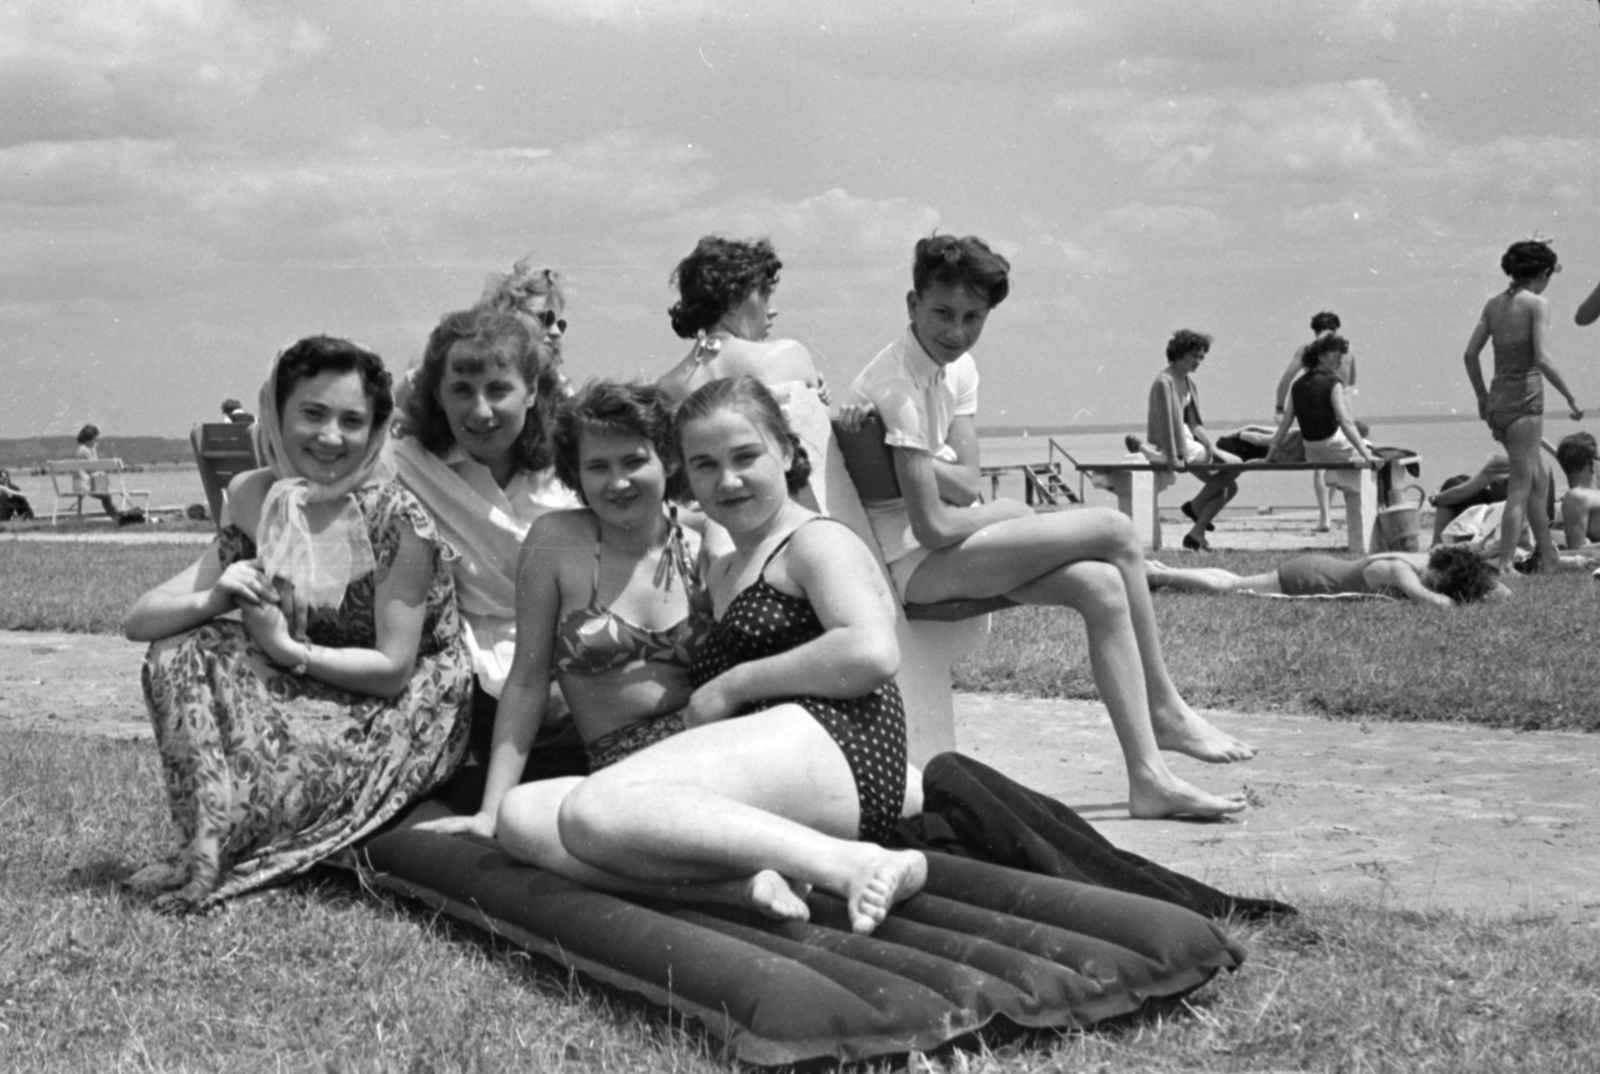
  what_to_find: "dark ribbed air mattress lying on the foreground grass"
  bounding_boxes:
[360,759,1291,1066]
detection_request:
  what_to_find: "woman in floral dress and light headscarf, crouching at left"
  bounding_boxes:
[123,336,472,911]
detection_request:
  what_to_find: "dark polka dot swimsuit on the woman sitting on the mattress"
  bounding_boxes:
[690,521,906,842]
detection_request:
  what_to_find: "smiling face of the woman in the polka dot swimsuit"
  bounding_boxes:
[678,407,794,535]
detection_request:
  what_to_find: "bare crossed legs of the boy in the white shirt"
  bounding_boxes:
[906,507,1256,816]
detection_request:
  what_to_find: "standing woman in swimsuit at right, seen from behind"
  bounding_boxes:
[1464,240,1584,575]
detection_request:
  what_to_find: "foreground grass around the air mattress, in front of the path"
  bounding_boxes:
[0,733,1600,1074]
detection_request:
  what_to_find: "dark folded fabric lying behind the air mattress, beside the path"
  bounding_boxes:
[896,752,1296,919]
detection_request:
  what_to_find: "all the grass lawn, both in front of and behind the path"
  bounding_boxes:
[9,538,1600,1074]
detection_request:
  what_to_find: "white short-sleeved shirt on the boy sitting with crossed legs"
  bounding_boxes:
[851,325,978,563]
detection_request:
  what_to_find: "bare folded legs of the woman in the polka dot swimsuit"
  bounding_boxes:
[518,704,928,933]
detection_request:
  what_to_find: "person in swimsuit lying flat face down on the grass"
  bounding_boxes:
[1144,544,1510,608]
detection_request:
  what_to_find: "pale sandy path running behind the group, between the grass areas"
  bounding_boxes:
[0,632,1600,924]
